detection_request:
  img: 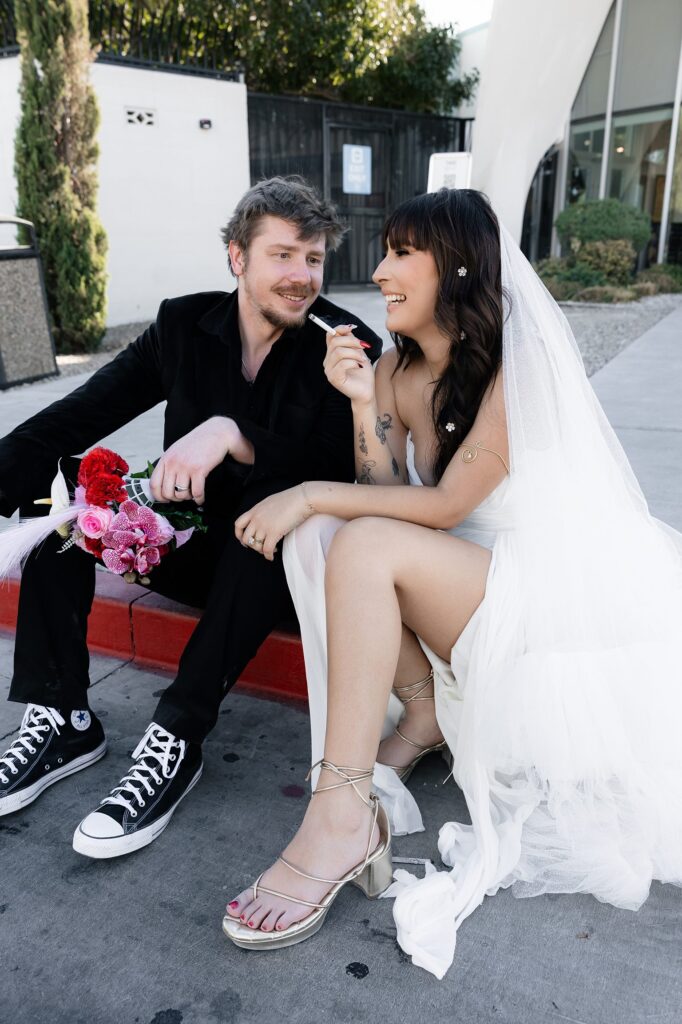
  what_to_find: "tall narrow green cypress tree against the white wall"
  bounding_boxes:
[14,0,106,352]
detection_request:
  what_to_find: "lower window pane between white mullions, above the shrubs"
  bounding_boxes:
[607,110,673,263]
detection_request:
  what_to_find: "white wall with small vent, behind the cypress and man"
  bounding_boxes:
[0,58,250,326]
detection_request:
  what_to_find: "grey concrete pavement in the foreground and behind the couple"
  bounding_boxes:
[0,297,682,1024]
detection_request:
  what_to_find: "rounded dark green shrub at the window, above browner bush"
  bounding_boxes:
[555,199,651,254]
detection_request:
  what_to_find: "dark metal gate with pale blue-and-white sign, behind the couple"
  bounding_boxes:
[249,92,471,285]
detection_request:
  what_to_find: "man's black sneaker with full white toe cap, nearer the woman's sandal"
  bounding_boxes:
[74,722,203,857]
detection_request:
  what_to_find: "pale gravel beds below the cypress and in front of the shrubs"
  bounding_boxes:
[31,295,682,385]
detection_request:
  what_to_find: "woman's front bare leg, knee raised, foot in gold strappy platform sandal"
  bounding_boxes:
[227,518,491,931]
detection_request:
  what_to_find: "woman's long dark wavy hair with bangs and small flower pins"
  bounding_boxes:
[383,188,504,480]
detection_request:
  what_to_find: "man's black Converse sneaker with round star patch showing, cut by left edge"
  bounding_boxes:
[0,705,106,816]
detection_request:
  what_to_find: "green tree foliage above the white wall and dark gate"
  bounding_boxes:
[91,0,478,113]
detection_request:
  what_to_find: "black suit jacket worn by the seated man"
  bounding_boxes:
[0,291,381,516]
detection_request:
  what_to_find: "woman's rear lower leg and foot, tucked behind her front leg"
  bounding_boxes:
[377,623,442,768]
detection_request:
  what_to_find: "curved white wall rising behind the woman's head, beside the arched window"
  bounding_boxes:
[472,0,611,240]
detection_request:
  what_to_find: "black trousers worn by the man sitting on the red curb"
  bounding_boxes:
[9,460,294,743]
